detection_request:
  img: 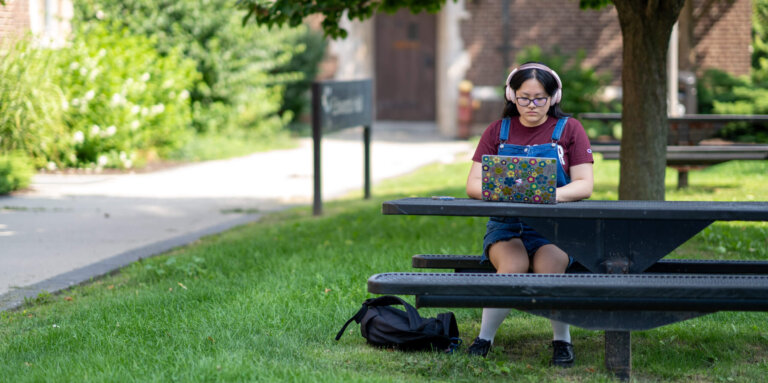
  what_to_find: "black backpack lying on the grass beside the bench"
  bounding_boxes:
[336,295,461,352]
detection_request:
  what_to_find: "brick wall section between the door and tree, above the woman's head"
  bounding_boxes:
[461,0,621,85]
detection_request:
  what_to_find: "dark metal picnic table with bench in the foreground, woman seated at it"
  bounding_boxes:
[368,198,768,379]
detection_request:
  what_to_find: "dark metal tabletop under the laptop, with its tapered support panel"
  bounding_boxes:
[382,198,768,274]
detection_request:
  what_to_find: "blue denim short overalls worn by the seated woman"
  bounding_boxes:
[481,117,572,262]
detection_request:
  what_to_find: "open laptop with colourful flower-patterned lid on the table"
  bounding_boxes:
[482,155,558,204]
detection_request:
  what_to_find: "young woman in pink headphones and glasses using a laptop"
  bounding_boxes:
[467,63,593,367]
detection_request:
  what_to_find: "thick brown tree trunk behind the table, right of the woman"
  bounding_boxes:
[613,0,685,200]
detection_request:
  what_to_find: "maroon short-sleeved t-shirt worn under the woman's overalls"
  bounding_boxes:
[472,116,594,175]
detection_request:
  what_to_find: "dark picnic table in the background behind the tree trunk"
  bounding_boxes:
[579,113,768,188]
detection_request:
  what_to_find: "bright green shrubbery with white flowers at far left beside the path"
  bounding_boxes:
[0,23,199,169]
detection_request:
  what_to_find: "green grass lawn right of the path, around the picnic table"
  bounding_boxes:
[0,155,768,382]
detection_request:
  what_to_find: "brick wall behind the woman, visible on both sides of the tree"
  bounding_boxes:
[461,0,752,121]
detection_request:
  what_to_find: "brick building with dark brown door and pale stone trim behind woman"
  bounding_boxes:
[329,0,752,136]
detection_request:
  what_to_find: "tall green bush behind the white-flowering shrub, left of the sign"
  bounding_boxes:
[75,0,312,136]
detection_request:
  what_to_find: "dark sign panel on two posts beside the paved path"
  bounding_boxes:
[312,79,373,215]
